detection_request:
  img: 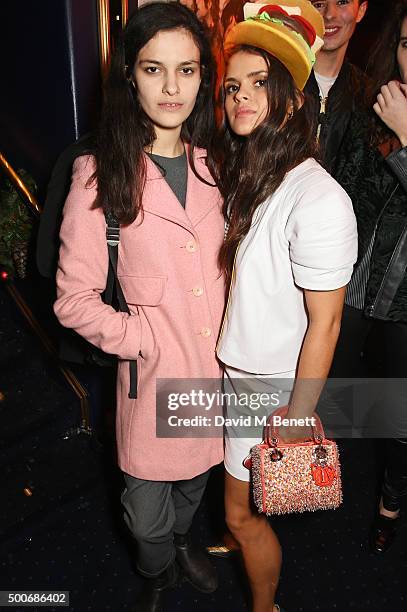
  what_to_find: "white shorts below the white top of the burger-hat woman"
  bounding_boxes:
[223,366,295,482]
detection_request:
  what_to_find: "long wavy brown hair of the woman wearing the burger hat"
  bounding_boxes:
[217,45,317,279]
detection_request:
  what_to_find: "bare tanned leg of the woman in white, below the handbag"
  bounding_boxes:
[225,472,281,612]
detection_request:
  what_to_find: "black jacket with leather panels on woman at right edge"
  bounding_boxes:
[335,113,407,323]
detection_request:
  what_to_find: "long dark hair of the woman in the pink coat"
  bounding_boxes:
[92,2,215,224]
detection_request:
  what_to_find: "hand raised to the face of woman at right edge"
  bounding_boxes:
[373,81,407,147]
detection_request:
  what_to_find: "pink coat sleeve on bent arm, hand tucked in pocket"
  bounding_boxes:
[54,157,141,359]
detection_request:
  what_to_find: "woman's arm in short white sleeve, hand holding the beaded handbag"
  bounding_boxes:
[280,173,357,439]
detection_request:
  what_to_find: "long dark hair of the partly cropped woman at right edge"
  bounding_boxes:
[367,0,407,144]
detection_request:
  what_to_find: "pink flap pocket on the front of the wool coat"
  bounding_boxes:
[118,274,167,306]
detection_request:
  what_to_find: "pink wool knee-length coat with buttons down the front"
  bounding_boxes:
[54,149,224,480]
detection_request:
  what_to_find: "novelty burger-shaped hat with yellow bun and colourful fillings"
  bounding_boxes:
[224,0,325,90]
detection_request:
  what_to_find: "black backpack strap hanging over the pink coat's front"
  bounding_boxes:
[105,212,137,399]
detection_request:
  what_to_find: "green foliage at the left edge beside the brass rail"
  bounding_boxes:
[0,169,37,276]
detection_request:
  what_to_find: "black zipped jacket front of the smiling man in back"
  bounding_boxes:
[304,61,367,176]
